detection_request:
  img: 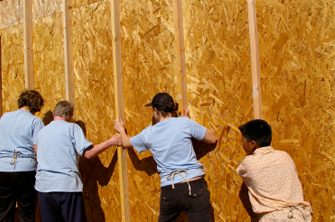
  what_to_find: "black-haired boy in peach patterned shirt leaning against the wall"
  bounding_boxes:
[236,119,313,222]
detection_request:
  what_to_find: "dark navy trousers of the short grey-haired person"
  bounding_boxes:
[38,192,86,222]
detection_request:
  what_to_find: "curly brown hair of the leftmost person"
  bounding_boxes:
[17,90,44,114]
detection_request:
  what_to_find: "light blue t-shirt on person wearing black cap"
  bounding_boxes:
[130,117,207,187]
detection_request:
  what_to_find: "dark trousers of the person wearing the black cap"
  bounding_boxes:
[158,178,211,222]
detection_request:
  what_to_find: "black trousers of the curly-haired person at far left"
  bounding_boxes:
[0,171,36,222]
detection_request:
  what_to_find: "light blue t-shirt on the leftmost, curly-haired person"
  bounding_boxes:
[0,109,44,172]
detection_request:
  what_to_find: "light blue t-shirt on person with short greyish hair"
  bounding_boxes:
[35,120,93,192]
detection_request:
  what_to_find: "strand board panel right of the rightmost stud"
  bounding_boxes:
[256,0,335,221]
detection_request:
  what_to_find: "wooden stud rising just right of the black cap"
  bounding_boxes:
[173,0,187,111]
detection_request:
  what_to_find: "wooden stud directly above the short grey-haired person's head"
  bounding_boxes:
[63,0,75,107]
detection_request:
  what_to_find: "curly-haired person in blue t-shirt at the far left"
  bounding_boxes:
[0,90,44,222]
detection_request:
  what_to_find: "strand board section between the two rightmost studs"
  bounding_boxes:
[183,0,253,221]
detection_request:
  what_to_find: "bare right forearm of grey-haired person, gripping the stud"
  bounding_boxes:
[83,134,121,159]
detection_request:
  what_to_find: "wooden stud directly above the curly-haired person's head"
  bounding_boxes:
[23,0,34,89]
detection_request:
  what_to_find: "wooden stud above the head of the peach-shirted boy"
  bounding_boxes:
[247,0,262,119]
